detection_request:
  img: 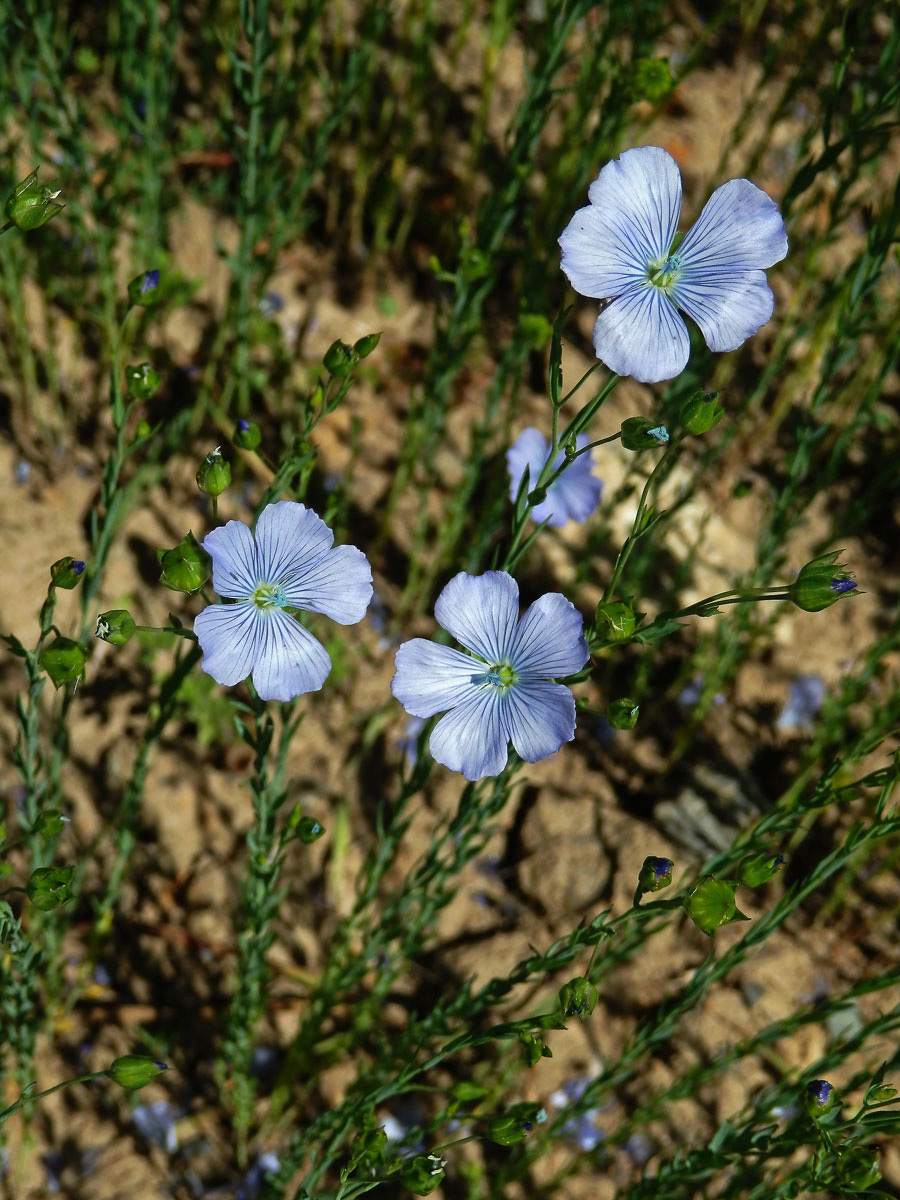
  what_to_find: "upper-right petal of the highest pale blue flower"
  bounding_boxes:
[678,179,787,275]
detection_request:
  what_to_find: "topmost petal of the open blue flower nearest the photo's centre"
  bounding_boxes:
[434,571,518,662]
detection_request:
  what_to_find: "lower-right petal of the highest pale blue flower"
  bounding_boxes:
[672,270,775,353]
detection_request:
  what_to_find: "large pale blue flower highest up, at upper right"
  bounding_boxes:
[559,146,787,383]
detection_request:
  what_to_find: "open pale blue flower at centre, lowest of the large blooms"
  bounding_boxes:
[391,571,588,780]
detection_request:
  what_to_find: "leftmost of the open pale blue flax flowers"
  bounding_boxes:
[193,500,372,700]
